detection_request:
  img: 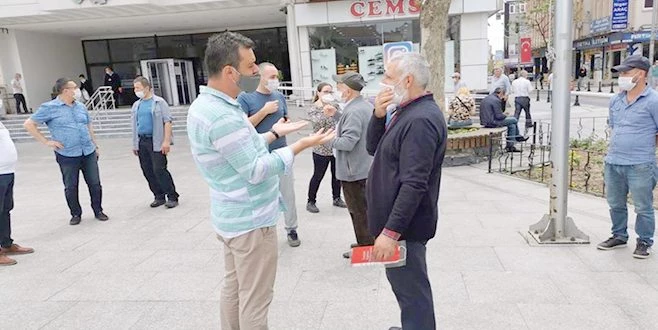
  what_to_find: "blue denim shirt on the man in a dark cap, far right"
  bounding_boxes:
[605,86,658,165]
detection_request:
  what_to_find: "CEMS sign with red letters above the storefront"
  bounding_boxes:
[350,0,420,18]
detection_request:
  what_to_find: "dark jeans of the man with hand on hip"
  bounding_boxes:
[55,152,103,217]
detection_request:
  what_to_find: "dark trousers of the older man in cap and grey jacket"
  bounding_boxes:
[341,179,375,245]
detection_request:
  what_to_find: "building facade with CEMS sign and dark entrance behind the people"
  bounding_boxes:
[0,0,502,112]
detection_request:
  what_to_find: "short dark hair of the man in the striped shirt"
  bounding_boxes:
[204,31,254,77]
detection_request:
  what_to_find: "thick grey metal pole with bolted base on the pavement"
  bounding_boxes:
[529,0,589,244]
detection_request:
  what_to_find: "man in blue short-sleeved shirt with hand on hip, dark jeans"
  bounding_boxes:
[23,78,109,225]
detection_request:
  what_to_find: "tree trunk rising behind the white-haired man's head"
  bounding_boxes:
[417,0,452,111]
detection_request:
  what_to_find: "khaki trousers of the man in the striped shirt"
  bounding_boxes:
[218,226,278,330]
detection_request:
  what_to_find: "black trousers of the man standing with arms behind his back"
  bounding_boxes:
[138,136,178,201]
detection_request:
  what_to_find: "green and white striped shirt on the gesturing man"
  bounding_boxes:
[187,86,294,238]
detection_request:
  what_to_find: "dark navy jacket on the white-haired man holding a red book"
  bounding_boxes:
[366,94,447,241]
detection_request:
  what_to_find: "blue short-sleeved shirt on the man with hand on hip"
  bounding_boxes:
[30,97,96,157]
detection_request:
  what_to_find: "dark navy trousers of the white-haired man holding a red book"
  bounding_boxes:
[386,241,436,330]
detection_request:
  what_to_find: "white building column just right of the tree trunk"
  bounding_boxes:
[458,13,489,89]
